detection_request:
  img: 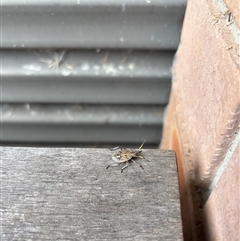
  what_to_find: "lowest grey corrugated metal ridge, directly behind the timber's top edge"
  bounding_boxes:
[1,104,163,144]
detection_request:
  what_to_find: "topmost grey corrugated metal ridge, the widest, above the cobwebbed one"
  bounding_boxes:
[1,0,186,49]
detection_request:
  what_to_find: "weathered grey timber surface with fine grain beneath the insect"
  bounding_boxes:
[0,147,183,241]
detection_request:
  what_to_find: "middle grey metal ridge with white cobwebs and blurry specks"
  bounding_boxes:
[0,49,174,104]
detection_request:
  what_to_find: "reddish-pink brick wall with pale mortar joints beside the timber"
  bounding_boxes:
[161,0,240,241]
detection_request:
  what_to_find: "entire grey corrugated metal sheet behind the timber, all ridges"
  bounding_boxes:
[0,0,185,145]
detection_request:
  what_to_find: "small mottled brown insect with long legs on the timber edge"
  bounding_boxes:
[106,141,149,172]
